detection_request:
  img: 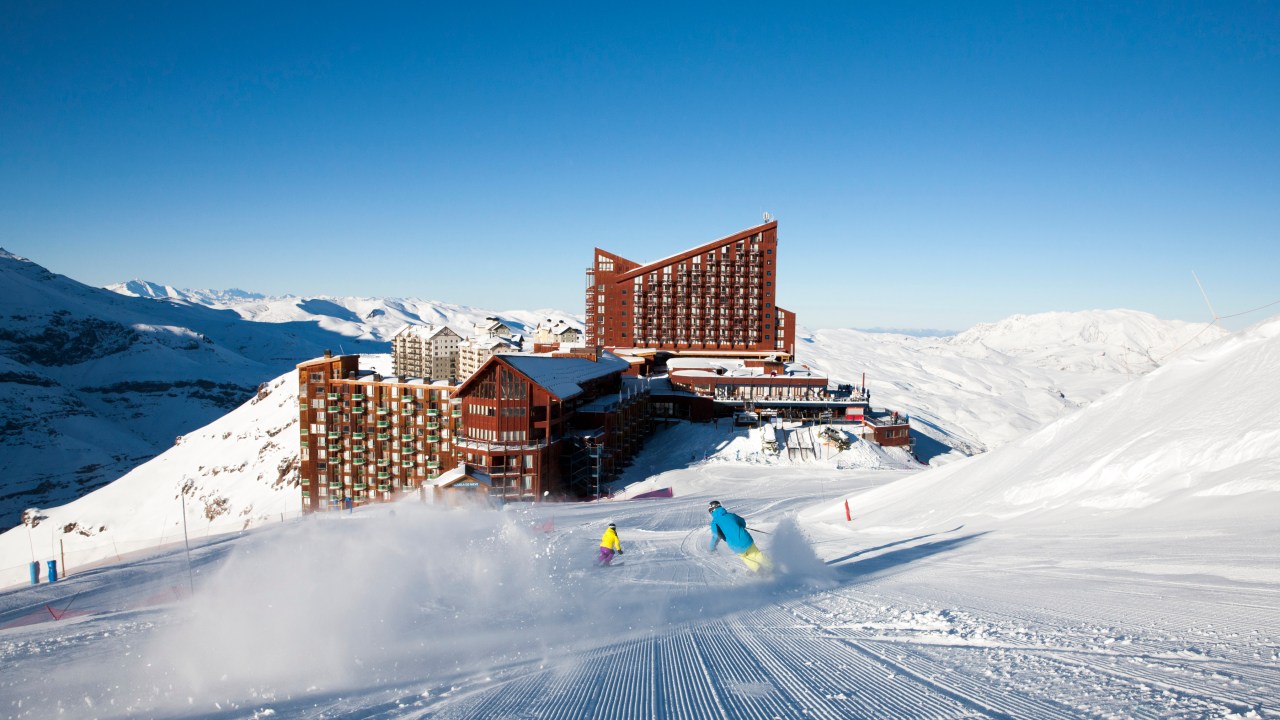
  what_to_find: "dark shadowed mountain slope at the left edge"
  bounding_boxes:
[0,250,387,528]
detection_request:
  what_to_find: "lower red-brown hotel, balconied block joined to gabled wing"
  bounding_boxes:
[297,348,653,504]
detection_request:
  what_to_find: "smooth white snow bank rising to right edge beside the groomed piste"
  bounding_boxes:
[834,311,1280,540]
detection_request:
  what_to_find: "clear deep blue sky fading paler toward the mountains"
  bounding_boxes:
[0,1,1280,329]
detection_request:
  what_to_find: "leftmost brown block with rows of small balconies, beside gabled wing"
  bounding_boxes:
[297,351,462,512]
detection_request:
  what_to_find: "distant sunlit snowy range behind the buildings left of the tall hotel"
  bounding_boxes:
[106,279,582,342]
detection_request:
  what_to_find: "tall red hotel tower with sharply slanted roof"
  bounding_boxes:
[586,220,795,359]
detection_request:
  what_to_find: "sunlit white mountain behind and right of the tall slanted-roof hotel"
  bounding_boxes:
[796,310,1226,457]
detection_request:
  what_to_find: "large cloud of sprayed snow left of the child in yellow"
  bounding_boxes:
[140,505,556,707]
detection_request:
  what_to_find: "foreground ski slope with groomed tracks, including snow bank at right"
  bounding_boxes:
[0,318,1280,719]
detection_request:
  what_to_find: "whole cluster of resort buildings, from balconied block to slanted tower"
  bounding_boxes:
[297,215,911,511]
